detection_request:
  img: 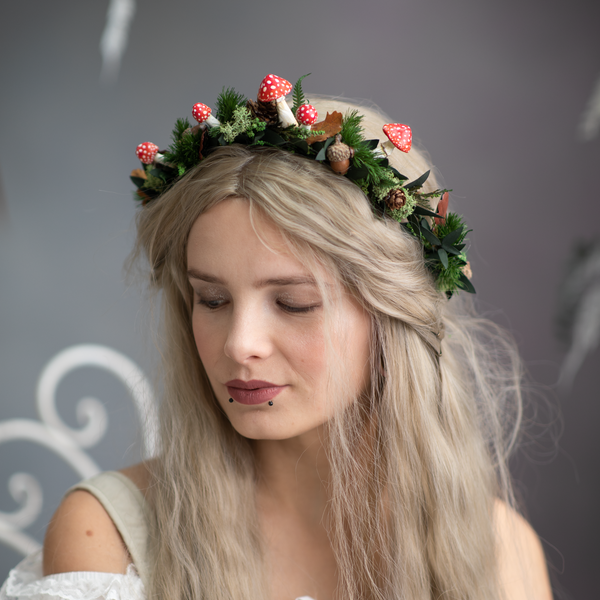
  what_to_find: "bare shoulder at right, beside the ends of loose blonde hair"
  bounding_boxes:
[494,500,552,600]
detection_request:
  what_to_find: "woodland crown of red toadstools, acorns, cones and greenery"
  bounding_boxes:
[131,75,475,297]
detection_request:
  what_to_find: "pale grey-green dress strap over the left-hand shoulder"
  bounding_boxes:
[67,471,151,588]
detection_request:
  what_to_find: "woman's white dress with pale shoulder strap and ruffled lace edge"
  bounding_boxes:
[0,471,313,600]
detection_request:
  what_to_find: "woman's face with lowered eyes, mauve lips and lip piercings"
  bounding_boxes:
[187,198,370,440]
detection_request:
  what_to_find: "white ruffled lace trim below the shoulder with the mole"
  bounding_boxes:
[0,550,146,600]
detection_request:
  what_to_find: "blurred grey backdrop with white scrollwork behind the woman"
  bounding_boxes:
[0,0,600,599]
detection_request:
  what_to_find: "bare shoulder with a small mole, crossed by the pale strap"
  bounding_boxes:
[43,463,150,575]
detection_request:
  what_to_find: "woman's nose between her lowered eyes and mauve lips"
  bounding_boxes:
[223,303,273,364]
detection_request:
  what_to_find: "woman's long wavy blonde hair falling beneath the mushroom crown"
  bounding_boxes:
[134,101,521,600]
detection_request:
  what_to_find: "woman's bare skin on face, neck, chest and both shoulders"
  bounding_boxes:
[44,199,552,600]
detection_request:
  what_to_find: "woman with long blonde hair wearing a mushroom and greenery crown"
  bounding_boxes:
[0,76,551,600]
